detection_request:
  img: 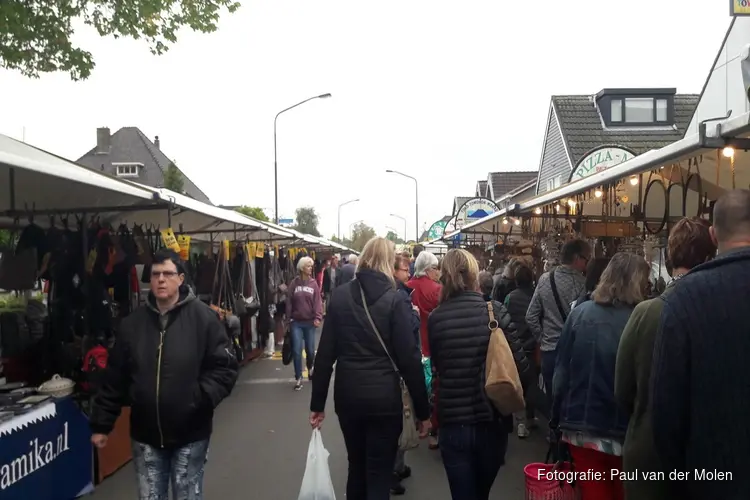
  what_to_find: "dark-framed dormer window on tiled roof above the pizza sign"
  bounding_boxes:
[596,89,675,127]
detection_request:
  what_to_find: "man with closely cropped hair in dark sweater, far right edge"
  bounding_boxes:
[651,190,750,500]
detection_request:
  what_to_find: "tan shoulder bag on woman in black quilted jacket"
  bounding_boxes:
[484,302,526,415]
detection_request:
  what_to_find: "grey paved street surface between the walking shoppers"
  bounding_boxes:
[90,338,546,500]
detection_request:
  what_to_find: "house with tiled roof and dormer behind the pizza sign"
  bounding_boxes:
[536,88,699,194]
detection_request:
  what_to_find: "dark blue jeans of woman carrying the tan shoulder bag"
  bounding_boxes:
[440,421,508,500]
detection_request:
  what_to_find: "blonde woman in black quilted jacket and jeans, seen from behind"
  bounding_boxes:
[427,249,530,500]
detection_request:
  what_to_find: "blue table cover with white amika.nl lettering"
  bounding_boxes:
[0,398,93,500]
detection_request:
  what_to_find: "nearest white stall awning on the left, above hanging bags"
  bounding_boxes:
[0,135,155,226]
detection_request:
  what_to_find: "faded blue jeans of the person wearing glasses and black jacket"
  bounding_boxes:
[132,440,208,500]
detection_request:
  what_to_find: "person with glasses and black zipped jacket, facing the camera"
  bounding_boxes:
[90,250,237,500]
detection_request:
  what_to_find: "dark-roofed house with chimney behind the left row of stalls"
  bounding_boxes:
[77,127,211,203]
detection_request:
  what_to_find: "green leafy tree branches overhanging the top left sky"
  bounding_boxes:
[0,0,240,80]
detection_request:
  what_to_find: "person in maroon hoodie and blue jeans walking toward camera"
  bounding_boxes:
[286,257,323,391]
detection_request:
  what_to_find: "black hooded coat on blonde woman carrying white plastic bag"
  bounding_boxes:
[310,269,430,420]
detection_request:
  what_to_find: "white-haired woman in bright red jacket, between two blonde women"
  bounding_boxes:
[406,252,442,450]
